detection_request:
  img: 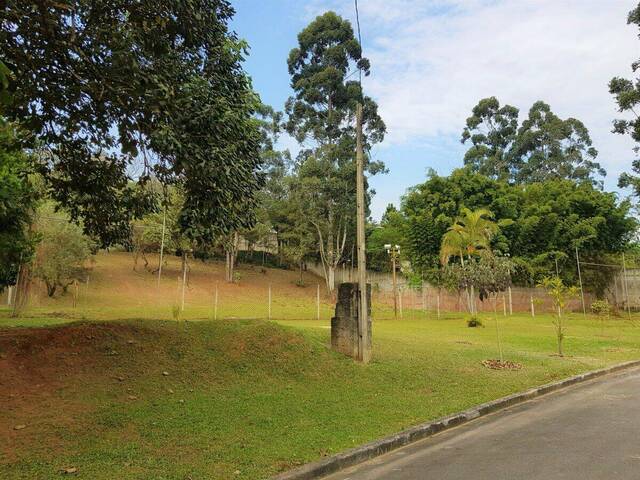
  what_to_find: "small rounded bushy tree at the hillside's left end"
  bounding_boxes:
[33,203,92,297]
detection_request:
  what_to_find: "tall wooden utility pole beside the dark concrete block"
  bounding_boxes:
[356,103,371,363]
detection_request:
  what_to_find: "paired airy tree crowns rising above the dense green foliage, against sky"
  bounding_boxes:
[461,97,606,184]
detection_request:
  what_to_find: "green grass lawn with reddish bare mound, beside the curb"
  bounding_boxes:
[5,311,640,480]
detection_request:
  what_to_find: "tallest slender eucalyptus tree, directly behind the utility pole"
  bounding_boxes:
[286,12,385,291]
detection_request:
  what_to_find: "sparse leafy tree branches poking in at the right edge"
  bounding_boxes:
[609,4,640,197]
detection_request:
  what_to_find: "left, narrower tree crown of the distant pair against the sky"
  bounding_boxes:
[461,97,519,180]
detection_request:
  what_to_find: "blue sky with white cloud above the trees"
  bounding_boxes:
[231,0,640,219]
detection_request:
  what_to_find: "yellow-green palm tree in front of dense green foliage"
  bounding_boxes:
[440,207,498,314]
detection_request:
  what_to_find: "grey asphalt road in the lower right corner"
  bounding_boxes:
[326,369,640,480]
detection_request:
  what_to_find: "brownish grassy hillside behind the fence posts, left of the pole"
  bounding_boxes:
[3,251,333,323]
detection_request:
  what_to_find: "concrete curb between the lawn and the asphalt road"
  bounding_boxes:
[273,360,640,480]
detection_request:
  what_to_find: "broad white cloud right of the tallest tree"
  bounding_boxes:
[307,0,640,186]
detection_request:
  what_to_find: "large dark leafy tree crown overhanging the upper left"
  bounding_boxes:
[0,0,261,244]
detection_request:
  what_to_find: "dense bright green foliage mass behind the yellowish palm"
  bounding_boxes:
[401,169,637,292]
